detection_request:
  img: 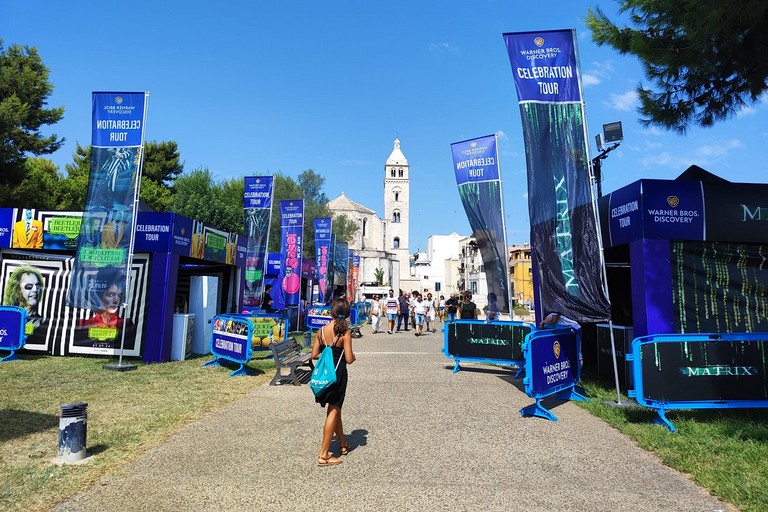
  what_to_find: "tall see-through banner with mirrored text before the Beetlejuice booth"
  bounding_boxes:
[67,92,149,332]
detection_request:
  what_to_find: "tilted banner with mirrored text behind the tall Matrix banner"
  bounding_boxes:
[451,135,511,313]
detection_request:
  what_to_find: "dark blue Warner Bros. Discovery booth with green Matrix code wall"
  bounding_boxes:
[584,166,768,387]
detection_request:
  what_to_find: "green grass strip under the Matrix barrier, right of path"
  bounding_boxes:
[577,376,768,512]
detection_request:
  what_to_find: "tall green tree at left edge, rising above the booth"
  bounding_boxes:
[0,39,64,198]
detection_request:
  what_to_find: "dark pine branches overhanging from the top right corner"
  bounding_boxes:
[586,0,768,133]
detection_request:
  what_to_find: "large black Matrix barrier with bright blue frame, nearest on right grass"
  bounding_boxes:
[626,332,768,432]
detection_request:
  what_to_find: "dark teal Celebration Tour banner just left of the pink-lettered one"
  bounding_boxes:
[241,176,274,309]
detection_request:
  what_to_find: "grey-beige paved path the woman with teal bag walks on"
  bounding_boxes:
[56,327,733,512]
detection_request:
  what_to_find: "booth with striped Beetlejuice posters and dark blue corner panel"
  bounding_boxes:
[0,208,245,362]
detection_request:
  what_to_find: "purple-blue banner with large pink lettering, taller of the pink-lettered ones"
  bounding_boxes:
[280,199,304,308]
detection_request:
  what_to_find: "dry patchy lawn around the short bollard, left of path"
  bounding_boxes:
[0,353,274,511]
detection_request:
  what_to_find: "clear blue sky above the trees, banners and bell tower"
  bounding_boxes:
[0,0,768,248]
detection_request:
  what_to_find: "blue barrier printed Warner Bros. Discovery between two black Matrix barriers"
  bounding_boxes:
[520,327,588,421]
